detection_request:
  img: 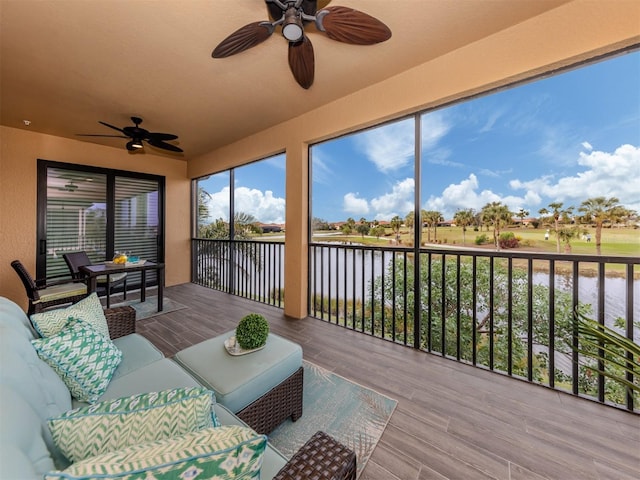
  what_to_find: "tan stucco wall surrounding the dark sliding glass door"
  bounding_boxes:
[0,127,190,308]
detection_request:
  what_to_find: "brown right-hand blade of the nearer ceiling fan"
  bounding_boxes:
[316,6,391,45]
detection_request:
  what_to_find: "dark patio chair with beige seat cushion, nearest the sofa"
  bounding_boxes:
[11,260,87,315]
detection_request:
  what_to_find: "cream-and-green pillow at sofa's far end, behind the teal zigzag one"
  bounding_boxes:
[31,292,109,338]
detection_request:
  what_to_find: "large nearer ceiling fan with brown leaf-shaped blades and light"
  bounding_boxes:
[211,0,391,89]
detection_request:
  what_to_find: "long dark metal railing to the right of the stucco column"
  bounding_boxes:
[309,243,640,411]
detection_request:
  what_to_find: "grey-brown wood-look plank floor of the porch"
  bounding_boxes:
[132,284,640,480]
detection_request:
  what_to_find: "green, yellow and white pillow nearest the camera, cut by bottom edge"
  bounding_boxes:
[44,425,267,480]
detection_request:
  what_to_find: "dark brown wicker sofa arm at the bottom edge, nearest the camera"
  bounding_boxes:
[273,432,356,480]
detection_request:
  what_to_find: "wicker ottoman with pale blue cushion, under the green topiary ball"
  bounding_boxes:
[174,332,304,434]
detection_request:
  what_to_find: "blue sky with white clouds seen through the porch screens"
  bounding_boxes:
[198,52,640,223]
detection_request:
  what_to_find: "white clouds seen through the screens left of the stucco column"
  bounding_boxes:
[209,187,285,223]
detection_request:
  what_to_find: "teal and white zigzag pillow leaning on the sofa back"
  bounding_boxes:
[31,320,122,403]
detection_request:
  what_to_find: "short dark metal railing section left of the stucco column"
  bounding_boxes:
[191,239,284,307]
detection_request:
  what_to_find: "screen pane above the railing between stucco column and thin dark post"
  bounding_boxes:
[311,118,415,245]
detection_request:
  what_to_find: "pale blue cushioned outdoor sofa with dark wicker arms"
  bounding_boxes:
[0,297,355,480]
